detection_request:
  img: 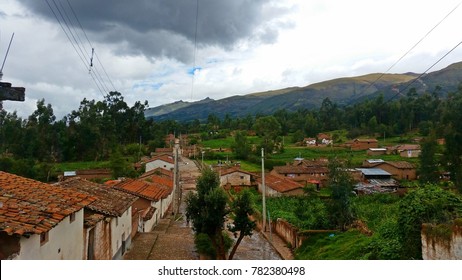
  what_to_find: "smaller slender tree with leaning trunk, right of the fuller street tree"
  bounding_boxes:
[228,191,256,260]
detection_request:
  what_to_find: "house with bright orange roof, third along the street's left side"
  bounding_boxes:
[112,176,173,232]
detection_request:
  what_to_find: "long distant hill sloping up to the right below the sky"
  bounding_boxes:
[145,62,462,121]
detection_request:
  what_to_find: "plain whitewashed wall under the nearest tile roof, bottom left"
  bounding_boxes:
[14,208,84,260]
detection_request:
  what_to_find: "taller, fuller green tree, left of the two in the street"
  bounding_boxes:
[186,168,229,259]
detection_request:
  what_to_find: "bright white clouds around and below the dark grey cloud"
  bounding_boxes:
[0,0,462,119]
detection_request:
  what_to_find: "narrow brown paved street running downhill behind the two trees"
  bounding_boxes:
[124,157,286,260]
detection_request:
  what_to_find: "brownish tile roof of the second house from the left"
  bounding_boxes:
[56,177,137,217]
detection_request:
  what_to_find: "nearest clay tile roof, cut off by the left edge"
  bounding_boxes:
[0,171,96,236]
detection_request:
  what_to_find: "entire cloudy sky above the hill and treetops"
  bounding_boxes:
[0,0,462,119]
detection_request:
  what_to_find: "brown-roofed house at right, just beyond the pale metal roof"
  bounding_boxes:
[363,159,417,180]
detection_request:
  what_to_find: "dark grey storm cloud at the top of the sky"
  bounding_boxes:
[19,0,287,61]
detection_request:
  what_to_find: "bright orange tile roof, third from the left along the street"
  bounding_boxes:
[113,179,173,201]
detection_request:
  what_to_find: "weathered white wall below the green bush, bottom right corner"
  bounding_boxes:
[421,224,462,260]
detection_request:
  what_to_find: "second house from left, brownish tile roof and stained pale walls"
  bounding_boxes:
[56,177,137,260]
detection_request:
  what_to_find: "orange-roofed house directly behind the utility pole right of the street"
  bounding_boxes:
[257,174,304,196]
